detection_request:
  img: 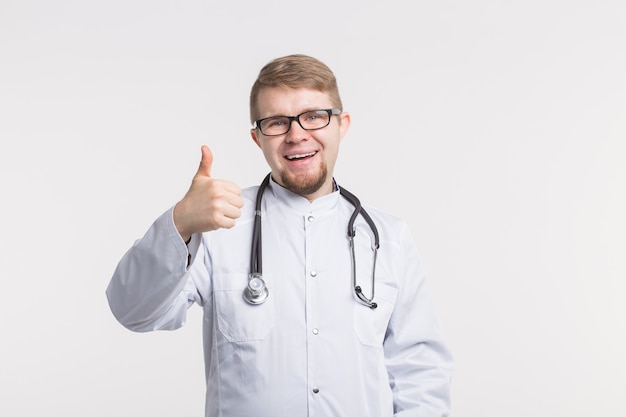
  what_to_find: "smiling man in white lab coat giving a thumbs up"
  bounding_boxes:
[107,55,452,417]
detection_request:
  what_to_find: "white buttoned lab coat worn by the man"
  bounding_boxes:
[107,182,452,417]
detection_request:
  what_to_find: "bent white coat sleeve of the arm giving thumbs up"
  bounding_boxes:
[106,208,208,332]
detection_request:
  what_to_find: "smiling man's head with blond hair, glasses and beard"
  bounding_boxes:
[250,55,350,201]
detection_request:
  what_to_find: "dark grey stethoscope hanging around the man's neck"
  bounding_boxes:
[243,173,380,309]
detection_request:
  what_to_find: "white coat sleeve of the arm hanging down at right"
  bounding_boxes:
[384,224,453,417]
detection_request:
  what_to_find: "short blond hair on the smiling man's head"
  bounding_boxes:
[250,54,343,123]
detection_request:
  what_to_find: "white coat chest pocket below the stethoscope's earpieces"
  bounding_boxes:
[354,283,398,347]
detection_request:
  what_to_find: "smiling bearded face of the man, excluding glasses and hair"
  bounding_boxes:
[250,88,350,201]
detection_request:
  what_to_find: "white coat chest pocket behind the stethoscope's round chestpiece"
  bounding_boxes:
[213,274,275,342]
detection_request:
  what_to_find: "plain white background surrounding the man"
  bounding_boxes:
[0,0,626,417]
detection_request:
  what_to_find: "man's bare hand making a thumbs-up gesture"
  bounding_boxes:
[174,145,243,241]
